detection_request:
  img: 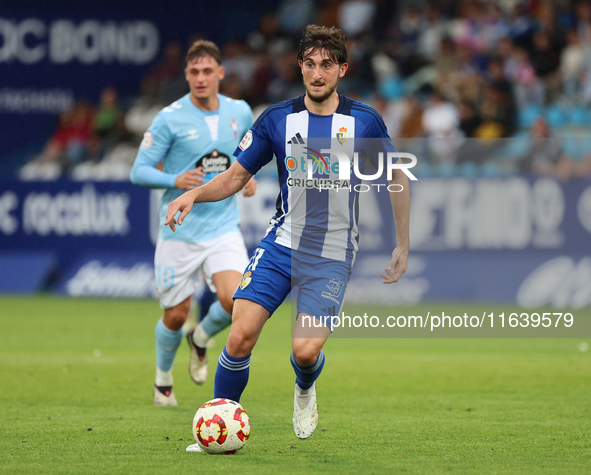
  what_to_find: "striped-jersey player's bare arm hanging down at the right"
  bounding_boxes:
[380,162,410,284]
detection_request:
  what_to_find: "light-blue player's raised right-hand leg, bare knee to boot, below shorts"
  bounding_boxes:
[187,270,242,384]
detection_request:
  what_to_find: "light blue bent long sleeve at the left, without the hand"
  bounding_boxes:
[130,113,178,188]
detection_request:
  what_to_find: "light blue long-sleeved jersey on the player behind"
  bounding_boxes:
[131,94,252,242]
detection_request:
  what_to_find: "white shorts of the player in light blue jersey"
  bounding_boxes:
[154,231,248,308]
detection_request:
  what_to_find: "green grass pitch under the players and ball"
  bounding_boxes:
[0,296,591,474]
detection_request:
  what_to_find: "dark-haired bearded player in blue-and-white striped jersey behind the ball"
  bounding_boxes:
[165,25,410,439]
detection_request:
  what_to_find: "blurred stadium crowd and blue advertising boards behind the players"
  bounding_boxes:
[0,0,591,307]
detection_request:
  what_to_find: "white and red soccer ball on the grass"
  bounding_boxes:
[193,398,250,454]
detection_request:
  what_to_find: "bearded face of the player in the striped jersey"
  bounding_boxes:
[299,50,348,102]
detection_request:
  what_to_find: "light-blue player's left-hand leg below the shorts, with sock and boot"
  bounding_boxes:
[154,297,191,406]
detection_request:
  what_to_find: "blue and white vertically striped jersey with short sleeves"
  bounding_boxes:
[234,95,396,264]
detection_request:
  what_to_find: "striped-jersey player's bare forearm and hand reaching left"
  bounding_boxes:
[164,161,252,231]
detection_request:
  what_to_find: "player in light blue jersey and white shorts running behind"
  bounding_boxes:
[131,41,256,406]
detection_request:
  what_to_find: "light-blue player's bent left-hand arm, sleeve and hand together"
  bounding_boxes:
[130,114,205,190]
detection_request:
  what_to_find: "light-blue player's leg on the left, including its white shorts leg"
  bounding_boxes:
[154,239,203,406]
